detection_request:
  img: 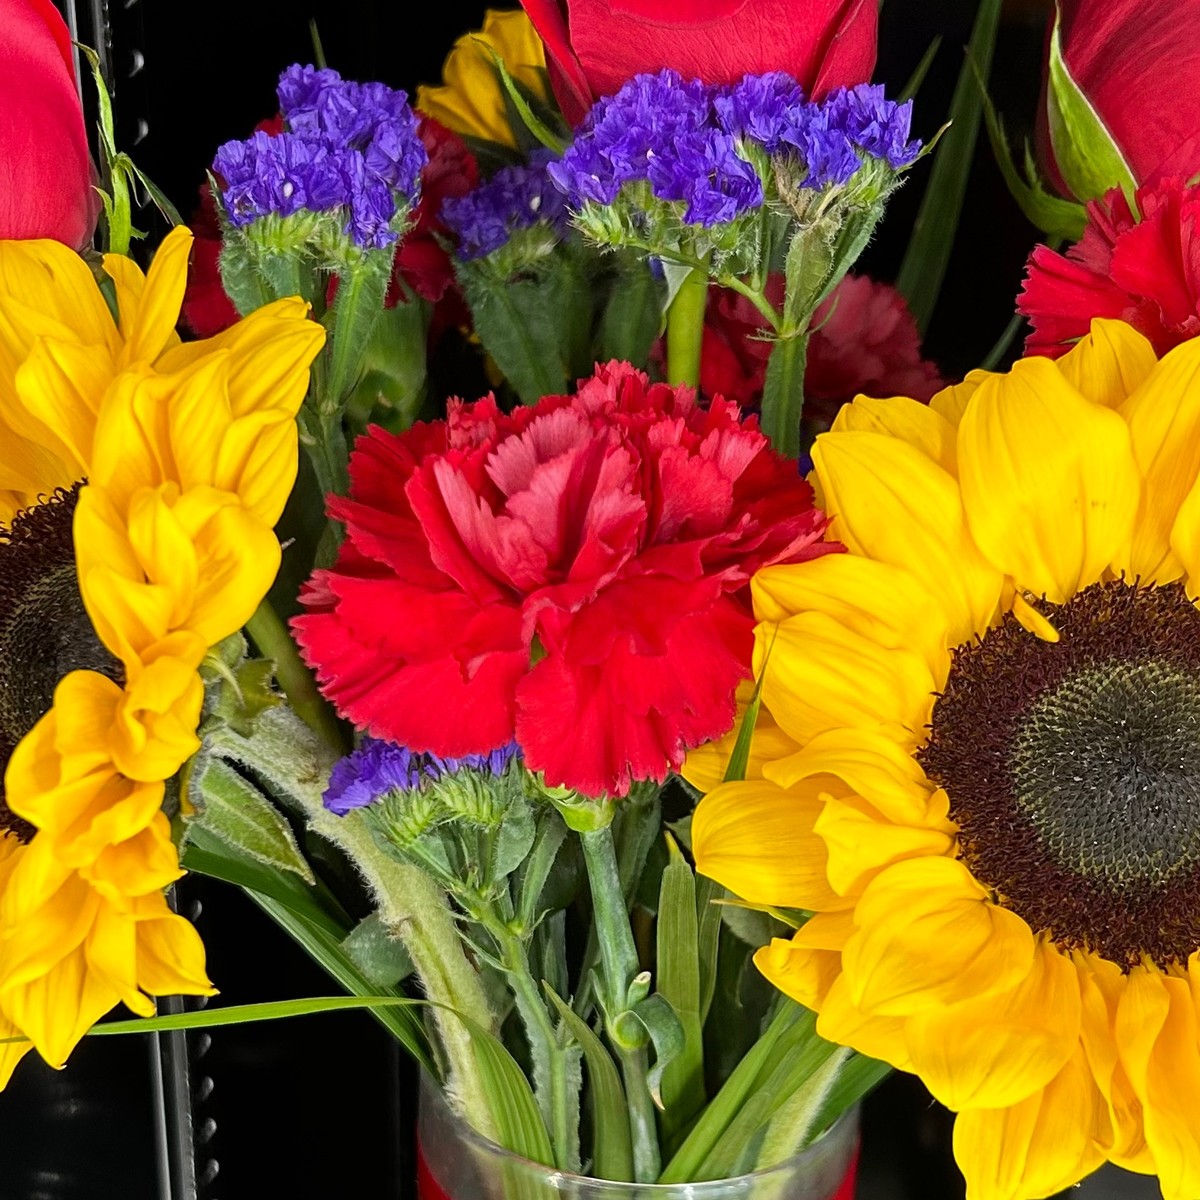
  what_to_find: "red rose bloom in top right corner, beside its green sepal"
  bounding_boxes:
[1060,0,1200,189]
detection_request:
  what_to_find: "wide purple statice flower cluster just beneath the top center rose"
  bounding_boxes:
[550,70,920,227]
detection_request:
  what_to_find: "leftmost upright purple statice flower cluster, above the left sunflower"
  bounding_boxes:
[212,66,427,250]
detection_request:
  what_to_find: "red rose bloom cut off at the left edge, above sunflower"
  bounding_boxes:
[0,0,100,250]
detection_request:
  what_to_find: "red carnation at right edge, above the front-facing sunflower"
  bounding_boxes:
[1016,179,1200,358]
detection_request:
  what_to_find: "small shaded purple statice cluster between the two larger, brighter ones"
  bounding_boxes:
[442,150,569,262]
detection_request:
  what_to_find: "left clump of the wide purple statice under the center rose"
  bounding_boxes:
[548,70,762,226]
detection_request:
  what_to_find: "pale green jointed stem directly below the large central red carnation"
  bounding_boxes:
[580,825,662,1183]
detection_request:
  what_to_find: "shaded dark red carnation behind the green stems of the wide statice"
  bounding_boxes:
[700,275,942,427]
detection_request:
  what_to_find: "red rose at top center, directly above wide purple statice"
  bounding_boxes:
[522,0,878,125]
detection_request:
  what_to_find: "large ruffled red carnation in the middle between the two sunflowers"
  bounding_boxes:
[293,362,838,796]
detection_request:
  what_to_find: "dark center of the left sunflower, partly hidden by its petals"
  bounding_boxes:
[0,486,121,836]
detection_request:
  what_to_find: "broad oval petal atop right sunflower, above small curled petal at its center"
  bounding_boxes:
[959,358,1139,604]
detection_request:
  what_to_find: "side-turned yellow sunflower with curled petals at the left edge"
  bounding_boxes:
[0,229,324,1086]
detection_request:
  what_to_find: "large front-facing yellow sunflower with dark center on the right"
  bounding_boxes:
[691,320,1200,1200]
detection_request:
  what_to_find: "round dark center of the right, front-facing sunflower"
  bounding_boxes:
[919,581,1200,965]
